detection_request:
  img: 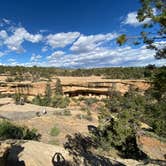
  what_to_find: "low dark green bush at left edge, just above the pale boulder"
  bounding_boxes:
[0,120,41,140]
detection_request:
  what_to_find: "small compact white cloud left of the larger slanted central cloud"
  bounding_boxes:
[46,32,80,48]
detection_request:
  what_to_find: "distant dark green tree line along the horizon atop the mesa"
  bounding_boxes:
[0,65,162,81]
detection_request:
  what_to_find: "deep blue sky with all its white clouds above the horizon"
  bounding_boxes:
[0,0,165,68]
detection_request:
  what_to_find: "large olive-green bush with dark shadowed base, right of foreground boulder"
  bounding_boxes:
[94,110,142,158]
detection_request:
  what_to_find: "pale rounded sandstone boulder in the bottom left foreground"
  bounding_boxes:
[7,141,72,166]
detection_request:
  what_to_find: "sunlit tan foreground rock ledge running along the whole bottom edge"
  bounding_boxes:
[0,140,166,166]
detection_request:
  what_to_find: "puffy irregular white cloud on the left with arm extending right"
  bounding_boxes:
[4,27,42,52]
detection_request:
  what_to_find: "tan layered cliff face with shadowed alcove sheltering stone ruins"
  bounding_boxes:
[0,76,150,96]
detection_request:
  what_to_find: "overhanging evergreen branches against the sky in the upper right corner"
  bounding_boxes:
[117,0,166,59]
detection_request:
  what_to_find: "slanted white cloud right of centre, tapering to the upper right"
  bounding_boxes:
[70,33,118,53]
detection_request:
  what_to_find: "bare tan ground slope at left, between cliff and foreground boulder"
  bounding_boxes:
[0,98,98,145]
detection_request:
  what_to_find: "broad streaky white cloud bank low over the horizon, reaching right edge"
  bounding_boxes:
[43,46,165,68]
